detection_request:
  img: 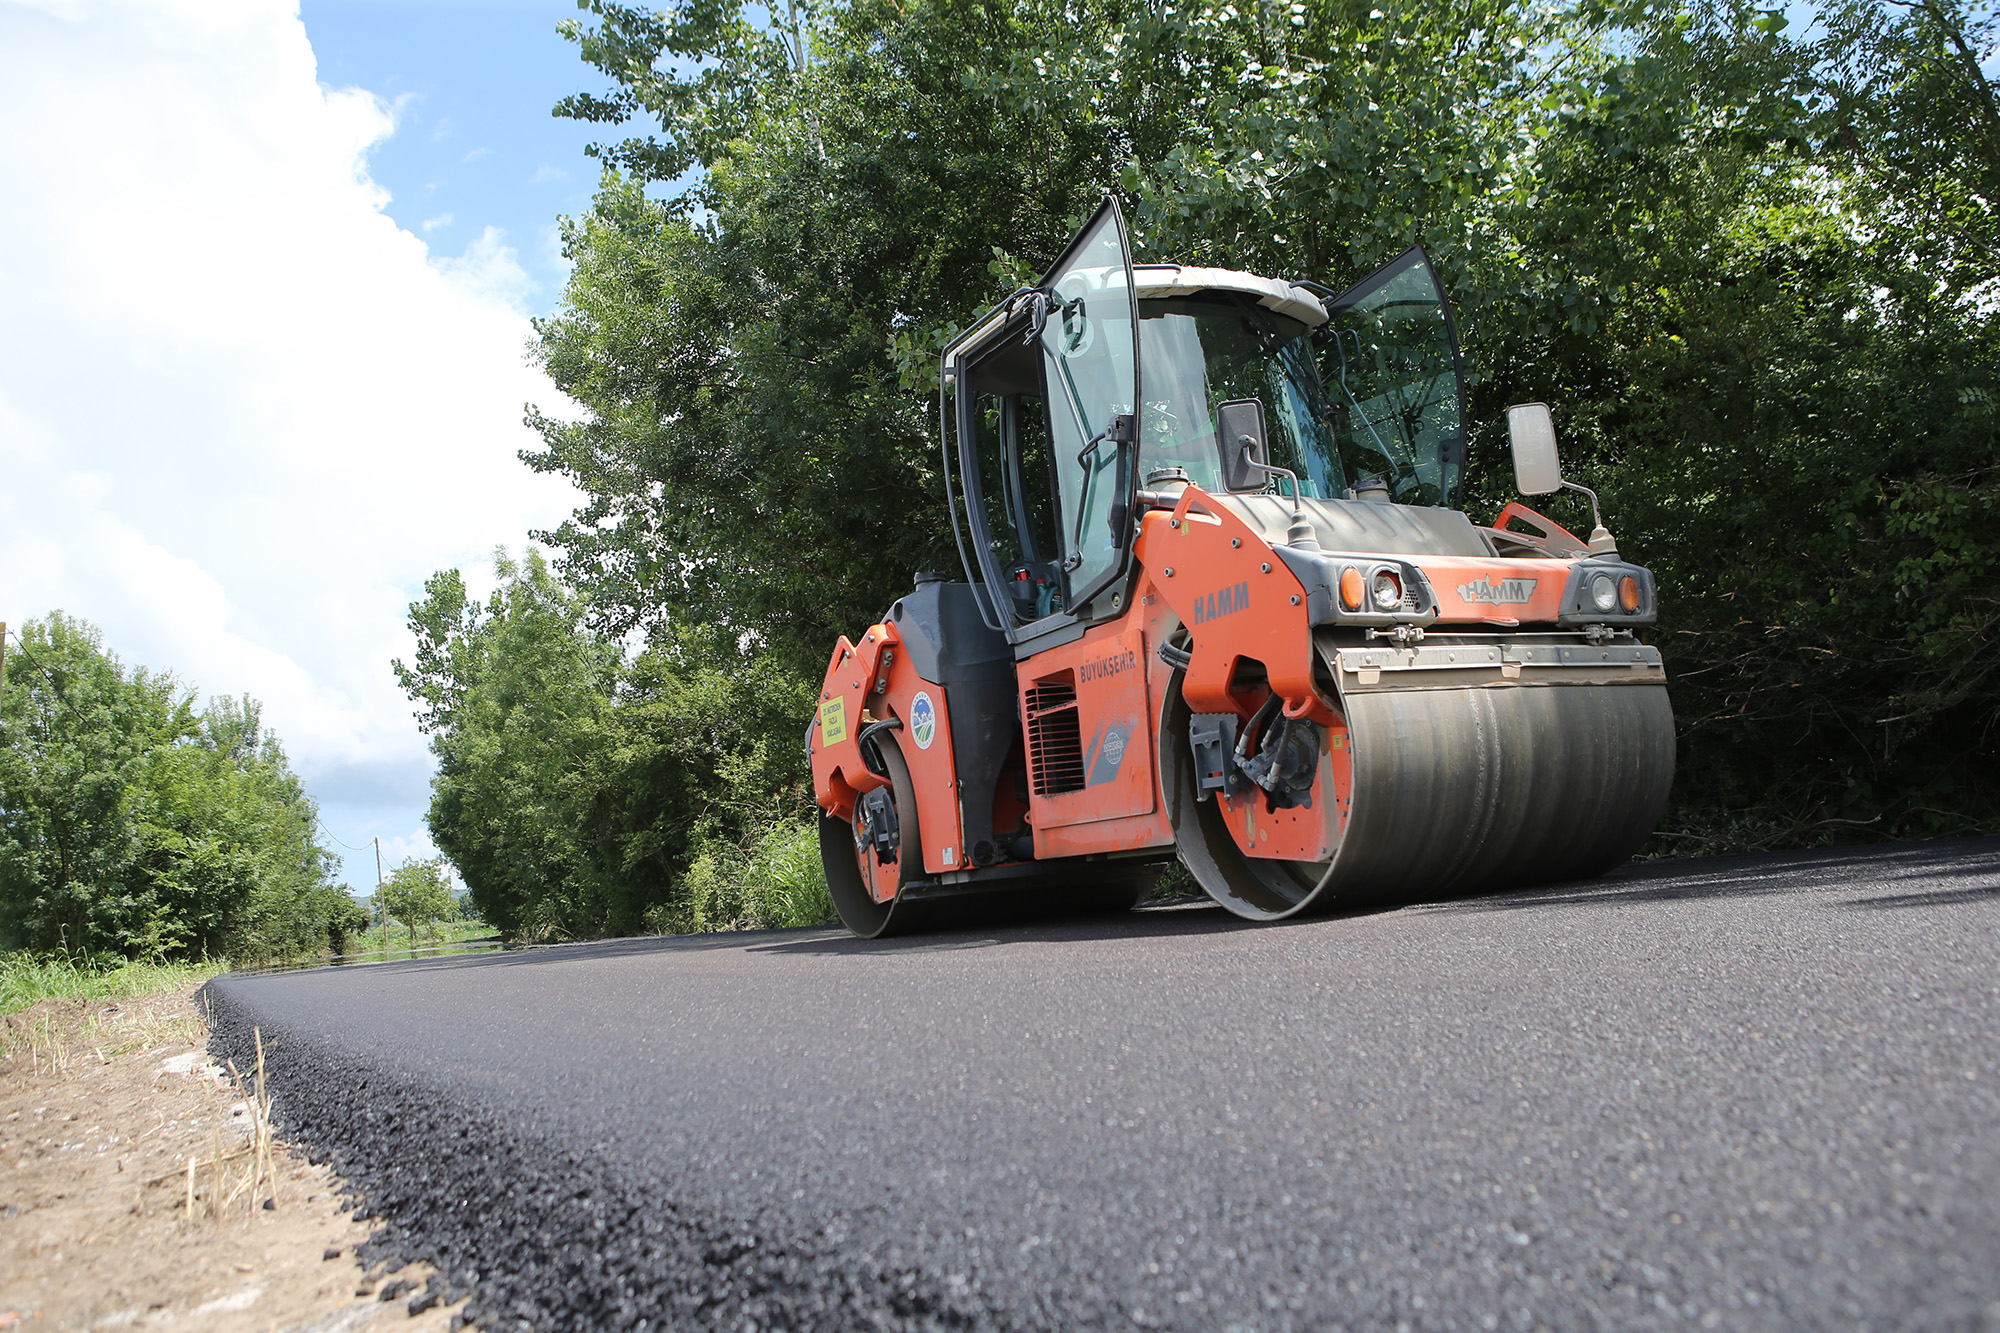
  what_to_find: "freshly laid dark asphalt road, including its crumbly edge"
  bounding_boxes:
[210,839,2000,1329]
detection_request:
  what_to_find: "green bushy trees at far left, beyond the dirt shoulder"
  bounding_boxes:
[0,612,352,961]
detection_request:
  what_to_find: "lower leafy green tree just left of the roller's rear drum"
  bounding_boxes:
[396,548,812,939]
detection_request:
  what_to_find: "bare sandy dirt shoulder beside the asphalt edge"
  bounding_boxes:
[0,991,458,1333]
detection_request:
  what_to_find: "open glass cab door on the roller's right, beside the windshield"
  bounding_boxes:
[1318,246,1466,506]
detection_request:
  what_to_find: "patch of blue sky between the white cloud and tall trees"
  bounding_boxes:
[300,0,618,314]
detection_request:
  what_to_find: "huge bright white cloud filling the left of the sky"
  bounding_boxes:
[0,0,574,885]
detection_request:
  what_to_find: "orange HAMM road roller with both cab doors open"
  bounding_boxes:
[806,200,1674,937]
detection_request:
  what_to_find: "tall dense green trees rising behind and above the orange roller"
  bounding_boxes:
[504,0,2000,849]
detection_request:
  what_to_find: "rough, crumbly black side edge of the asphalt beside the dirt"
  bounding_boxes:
[198,977,996,1333]
